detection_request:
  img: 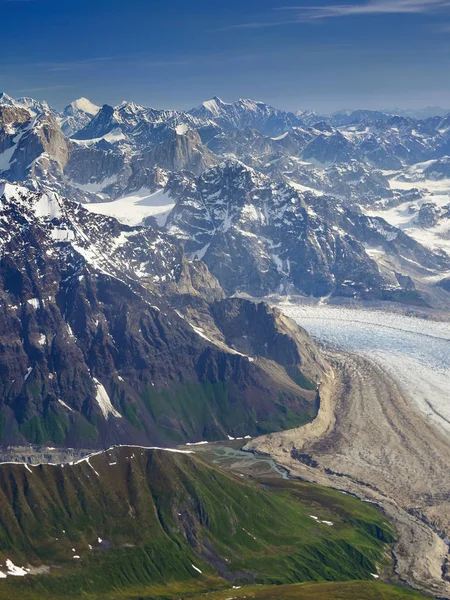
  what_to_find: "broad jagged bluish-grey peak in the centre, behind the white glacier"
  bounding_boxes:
[166,161,390,296]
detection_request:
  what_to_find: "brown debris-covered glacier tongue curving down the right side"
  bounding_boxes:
[245,352,450,598]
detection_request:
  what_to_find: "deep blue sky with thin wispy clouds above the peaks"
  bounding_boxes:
[0,0,450,113]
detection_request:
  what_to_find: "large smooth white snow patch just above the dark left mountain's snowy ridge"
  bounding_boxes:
[85,188,175,226]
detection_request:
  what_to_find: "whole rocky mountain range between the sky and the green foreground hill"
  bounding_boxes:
[0,89,450,447]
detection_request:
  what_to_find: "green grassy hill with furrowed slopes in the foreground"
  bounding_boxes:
[0,447,418,600]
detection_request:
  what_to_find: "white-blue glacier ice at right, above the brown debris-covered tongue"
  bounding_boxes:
[277,301,450,432]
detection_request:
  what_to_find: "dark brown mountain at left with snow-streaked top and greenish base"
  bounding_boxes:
[0,183,326,447]
